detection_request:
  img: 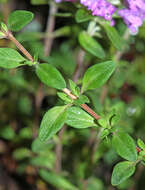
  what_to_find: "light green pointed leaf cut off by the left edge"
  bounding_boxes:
[0,48,26,69]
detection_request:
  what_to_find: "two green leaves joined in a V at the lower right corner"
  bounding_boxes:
[111,132,137,185]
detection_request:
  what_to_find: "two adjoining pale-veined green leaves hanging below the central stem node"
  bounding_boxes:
[39,106,96,141]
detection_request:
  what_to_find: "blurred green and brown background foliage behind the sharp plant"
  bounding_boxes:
[0,0,145,190]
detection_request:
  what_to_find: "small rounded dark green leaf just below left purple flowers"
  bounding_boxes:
[75,9,93,23]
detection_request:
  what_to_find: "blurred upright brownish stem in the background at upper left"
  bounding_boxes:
[44,3,57,56]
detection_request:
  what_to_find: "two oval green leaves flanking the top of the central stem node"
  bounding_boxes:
[36,61,115,92]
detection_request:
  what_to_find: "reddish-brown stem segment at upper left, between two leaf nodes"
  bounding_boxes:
[6,31,34,62]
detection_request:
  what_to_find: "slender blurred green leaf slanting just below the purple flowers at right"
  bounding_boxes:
[103,24,125,50]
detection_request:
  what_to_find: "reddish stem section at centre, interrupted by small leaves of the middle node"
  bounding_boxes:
[63,88,100,120]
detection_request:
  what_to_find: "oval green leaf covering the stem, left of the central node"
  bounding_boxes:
[36,63,66,90]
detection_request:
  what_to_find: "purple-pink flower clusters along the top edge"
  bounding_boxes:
[55,0,145,34]
